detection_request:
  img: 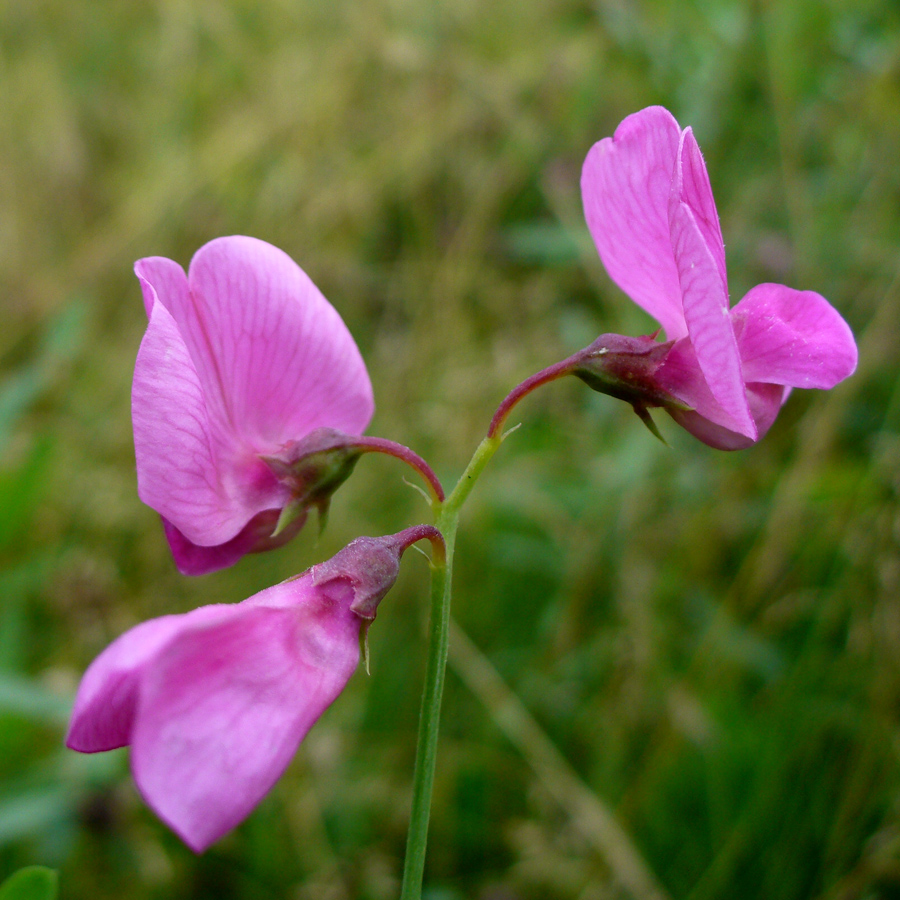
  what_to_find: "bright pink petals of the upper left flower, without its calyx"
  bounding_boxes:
[132,237,374,575]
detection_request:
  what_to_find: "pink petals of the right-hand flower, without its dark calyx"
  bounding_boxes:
[581,106,857,450]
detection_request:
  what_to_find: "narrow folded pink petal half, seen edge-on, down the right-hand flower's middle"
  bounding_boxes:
[669,134,757,440]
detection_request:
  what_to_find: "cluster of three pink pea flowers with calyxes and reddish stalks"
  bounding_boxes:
[67,107,856,852]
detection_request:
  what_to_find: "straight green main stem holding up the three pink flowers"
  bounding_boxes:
[400,435,502,900]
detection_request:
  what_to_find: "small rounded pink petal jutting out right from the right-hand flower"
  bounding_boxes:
[731,284,857,389]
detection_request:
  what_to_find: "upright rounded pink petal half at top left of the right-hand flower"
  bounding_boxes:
[581,106,687,340]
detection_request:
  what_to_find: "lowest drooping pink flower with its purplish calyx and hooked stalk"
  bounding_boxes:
[66,525,443,852]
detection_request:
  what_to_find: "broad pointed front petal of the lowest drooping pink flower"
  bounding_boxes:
[131,592,360,852]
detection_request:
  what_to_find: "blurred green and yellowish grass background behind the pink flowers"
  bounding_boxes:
[0,0,900,900]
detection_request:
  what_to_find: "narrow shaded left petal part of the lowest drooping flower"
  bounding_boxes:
[66,606,236,753]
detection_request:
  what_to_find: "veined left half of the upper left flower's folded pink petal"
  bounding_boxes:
[131,302,284,546]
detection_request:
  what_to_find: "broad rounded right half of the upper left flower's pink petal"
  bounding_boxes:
[173,237,374,453]
